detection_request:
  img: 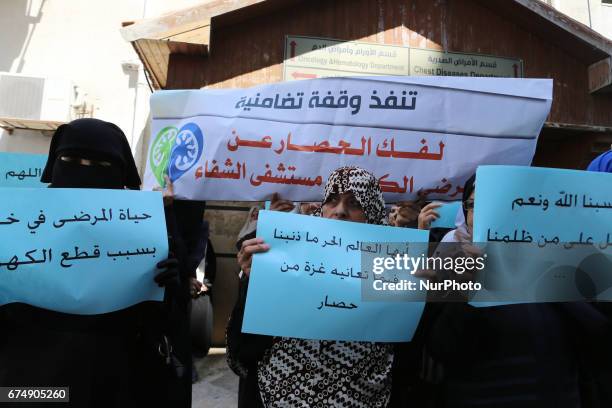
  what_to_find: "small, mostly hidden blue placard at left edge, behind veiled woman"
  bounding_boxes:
[0,152,47,187]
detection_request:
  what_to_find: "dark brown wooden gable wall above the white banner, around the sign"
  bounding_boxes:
[168,0,612,126]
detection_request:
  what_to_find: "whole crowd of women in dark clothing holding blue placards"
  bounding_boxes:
[0,119,612,408]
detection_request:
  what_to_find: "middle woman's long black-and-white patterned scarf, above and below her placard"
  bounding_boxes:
[257,167,393,408]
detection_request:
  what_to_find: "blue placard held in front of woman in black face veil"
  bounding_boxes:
[0,188,168,314]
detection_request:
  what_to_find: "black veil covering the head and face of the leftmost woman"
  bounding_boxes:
[41,118,140,190]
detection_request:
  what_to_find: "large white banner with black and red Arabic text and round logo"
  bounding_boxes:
[145,77,552,202]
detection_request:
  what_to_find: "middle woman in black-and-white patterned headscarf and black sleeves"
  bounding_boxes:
[227,167,416,408]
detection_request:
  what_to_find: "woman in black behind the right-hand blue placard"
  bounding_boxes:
[426,176,581,408]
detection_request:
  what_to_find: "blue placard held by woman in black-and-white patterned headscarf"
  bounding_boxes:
[242,211,429,342]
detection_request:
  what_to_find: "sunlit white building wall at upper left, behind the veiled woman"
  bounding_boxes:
[0,0,203,171]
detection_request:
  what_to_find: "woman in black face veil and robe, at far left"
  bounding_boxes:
[0,119,186,408]
